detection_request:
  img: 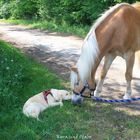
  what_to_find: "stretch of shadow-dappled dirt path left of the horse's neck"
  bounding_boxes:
[0,23,82,79]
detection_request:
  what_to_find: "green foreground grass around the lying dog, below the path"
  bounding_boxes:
[0,41,140,140]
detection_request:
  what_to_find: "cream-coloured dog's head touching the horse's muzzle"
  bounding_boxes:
[51,89,72,100]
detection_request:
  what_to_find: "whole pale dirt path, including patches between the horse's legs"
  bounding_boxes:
[0,23,140,115]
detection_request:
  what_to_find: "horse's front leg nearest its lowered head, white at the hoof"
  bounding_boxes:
[94,53,116,97]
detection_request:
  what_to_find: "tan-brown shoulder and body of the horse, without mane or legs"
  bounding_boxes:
[97,4,140,53]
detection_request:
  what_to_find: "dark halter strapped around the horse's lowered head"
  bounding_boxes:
[73,81,96,98]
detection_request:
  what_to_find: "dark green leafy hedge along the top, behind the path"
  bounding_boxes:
[0,0,135,25]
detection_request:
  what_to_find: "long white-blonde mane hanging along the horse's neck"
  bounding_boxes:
[73,3,129,85]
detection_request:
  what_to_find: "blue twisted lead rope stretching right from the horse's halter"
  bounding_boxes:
[91,96,140,103]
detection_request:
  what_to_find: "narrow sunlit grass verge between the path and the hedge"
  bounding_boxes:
[0,20,90,37]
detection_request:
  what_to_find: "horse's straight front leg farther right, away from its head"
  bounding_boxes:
[123,52,135,99]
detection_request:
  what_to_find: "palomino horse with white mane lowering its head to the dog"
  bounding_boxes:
[71,3,140,103]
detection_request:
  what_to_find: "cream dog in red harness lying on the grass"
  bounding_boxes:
[23,89,72,119]
